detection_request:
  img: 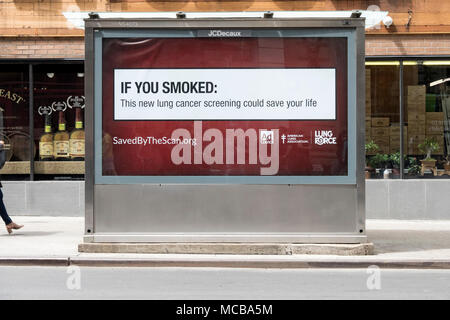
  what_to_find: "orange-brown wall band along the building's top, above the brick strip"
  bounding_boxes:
[0,0,450,37]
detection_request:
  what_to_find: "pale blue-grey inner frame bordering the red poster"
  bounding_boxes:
[94,28,357,184]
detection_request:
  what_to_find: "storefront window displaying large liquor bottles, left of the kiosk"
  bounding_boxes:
[33,64,85,180]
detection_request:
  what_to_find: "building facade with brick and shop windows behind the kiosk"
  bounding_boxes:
[0,0,450,219]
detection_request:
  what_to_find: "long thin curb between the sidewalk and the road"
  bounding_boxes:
[0,257,450,269]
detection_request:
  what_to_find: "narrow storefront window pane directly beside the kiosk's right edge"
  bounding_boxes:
[366,61,401,179]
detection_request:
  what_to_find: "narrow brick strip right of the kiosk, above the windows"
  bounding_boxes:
[366,34,450,56]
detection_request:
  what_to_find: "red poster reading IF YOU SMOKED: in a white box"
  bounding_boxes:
[102,37,348,176]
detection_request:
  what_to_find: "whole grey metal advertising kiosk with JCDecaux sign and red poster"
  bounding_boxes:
[84,12,366,243]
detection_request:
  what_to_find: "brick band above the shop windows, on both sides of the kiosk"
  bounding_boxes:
[0,34,450,59]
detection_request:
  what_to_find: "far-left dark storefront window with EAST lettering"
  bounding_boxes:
[0,64,31,180]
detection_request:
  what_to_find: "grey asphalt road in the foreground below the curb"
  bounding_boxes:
[0,266,450,300]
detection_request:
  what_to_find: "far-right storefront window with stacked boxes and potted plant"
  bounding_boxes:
[404,60,450,178]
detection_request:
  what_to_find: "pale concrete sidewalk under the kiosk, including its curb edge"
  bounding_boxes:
[0,216,450,269]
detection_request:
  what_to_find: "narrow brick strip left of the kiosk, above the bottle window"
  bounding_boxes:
[0,37,84,59]
